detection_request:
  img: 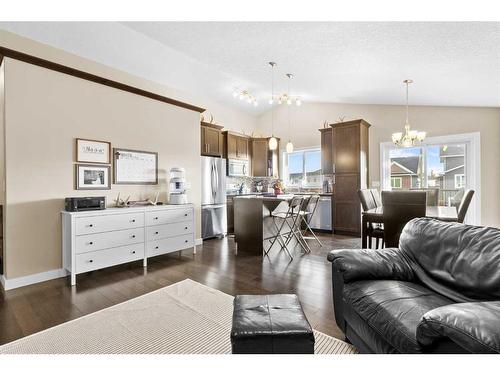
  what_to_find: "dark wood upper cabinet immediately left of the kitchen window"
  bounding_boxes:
[251,138,279,178]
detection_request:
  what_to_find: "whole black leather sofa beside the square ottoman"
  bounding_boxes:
[328,218,500,353]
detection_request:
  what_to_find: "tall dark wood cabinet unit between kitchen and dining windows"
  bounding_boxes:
[320,120,370,235]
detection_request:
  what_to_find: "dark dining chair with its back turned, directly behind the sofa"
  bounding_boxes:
[382,190,427,247]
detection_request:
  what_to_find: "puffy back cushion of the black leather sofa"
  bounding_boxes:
[399,218,500,302]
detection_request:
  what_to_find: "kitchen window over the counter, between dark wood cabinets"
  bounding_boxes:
[283,148,321,188]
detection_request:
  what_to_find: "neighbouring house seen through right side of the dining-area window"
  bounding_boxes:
[439,145,465,190]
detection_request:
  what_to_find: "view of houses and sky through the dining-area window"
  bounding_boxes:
[389,143,467,205]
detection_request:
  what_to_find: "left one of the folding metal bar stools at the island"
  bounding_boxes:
[264,196,307,260]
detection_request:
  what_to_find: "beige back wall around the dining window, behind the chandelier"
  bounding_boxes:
[257,103,500,227]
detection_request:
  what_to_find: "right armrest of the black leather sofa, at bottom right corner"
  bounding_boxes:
[417,301,500,353]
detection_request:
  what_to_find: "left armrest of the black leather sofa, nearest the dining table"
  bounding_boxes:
[328,248,414,283]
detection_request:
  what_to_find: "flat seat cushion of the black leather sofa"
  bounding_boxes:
[343,280,453,353]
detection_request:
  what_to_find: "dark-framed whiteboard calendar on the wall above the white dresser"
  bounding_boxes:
[113,148,158,185]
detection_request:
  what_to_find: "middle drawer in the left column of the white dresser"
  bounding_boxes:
[75,228,144,254]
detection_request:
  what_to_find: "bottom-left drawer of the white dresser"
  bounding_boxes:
[76,243,144,273]
